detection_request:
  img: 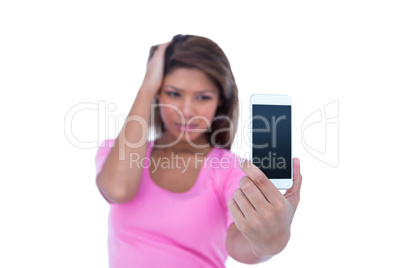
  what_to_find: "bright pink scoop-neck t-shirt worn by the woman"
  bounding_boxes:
[96,140,245,268]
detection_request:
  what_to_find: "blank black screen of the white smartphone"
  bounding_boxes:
[252,104,292,179]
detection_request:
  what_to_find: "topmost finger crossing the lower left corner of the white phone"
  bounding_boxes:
[242,160,283,204]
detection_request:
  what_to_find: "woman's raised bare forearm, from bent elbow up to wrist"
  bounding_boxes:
[96,87,154,203]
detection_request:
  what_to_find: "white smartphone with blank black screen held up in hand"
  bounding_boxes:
[250,94,293,189]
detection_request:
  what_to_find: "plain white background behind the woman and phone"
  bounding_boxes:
[0,0,402,267]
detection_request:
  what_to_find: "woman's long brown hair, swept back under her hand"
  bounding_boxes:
[149,34,239,150]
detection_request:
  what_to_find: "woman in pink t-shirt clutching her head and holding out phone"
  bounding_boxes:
[96,35,301,268]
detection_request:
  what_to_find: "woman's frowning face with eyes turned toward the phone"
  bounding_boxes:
[159,68,219,146]
